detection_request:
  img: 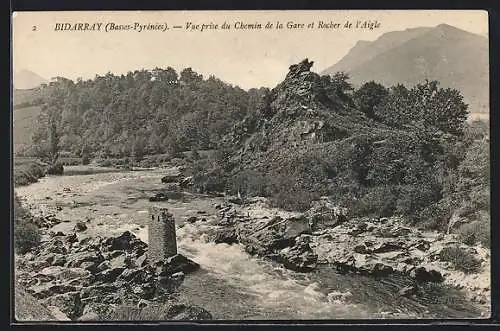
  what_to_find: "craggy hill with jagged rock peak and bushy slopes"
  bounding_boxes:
[193,59,489,237]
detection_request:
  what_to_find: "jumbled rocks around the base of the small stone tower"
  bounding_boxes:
[16,231,211,320]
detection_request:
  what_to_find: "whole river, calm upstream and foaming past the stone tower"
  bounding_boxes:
[16,167,479,320]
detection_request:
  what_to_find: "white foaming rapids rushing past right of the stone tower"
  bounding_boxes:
[177,224,368,319]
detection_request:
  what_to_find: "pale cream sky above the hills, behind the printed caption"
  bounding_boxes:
[12,10,488,89]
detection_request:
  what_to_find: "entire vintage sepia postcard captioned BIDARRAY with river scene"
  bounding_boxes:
[12,10,491,322]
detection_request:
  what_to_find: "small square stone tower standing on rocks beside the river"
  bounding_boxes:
[148,207,177,262]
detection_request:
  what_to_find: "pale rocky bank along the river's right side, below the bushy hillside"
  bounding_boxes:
[202,198,491,316]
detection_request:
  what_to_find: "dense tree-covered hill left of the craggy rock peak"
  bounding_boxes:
[30,67,266,162]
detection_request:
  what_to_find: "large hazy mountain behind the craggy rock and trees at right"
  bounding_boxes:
[323,24,489,113]
